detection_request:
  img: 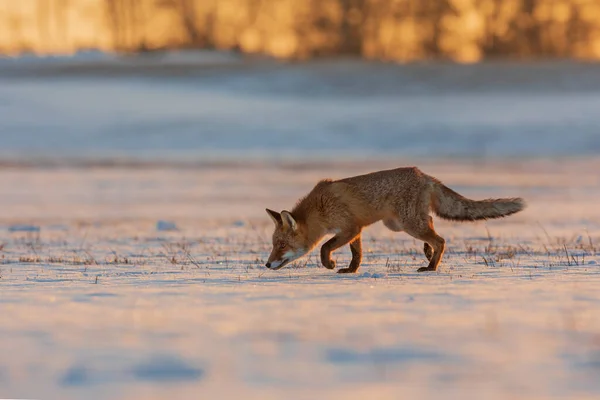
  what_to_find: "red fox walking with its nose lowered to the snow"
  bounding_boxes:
[266,167,526,273]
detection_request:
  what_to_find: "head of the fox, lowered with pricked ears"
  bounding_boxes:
[265,208,310,269]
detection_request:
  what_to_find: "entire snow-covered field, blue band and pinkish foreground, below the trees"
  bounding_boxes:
[0,52,600,399]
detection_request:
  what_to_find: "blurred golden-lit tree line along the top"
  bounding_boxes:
[0,0,600,61]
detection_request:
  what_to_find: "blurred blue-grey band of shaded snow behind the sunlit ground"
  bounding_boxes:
[0,55,600,162]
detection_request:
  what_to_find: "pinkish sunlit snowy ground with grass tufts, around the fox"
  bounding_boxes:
[0,158,600,399]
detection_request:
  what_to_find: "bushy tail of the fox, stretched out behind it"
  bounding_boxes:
[431,180,526,221]
